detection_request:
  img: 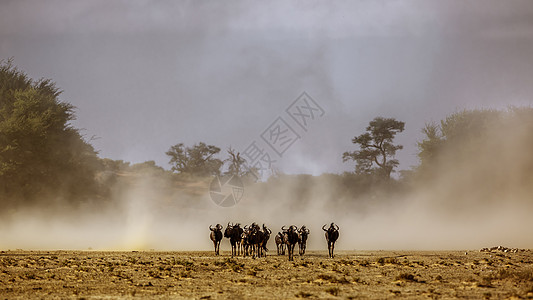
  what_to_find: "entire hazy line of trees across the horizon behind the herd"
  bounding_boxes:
[0,61,533,208]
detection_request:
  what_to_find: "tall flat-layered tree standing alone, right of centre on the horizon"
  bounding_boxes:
[342,117,405,179]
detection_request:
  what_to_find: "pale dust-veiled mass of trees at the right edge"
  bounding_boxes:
[414,107,533,204]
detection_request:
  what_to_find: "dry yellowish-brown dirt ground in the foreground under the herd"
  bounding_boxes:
[0,251,533,299]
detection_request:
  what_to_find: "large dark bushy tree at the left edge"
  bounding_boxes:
[0,60,99,205]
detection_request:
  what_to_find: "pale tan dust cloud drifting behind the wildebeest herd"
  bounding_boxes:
[0,110,533,254]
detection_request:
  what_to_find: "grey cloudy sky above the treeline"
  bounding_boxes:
[0,0,533,174]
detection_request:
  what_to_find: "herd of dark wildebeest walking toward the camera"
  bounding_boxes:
[209,222,339,260]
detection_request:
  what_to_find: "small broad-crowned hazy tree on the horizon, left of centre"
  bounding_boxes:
[166,143,223,176]
